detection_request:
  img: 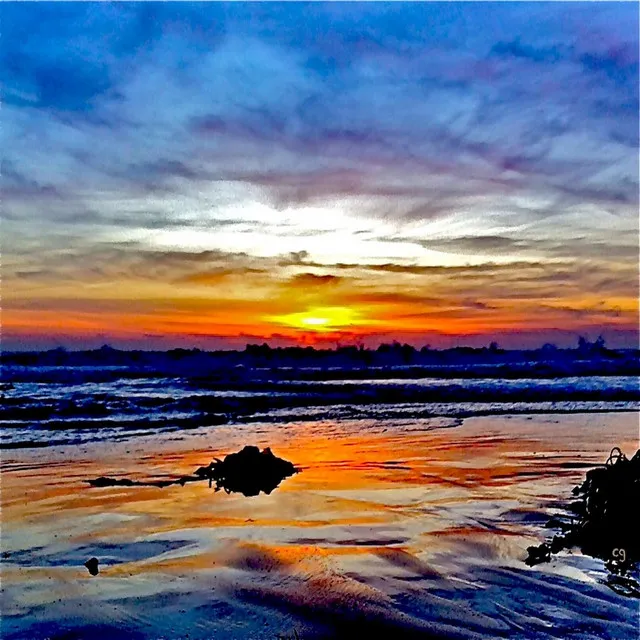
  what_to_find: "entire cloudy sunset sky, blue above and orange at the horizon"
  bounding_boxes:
[0,2,638,349]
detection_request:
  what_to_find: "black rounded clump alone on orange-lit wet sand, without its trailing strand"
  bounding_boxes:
[196,446,297,496]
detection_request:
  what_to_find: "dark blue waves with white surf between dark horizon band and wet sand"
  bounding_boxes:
[0,366,640,449]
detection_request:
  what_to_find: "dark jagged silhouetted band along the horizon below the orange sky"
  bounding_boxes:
[2,337,640,380]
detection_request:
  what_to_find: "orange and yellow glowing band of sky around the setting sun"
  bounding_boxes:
[2,258,638,348]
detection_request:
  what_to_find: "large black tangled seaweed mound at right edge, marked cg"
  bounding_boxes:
[525,447,640,595]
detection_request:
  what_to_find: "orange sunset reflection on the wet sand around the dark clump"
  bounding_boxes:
[2,415,634,588]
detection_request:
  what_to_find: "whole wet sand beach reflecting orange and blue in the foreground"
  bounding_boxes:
[0,413,640,640]
